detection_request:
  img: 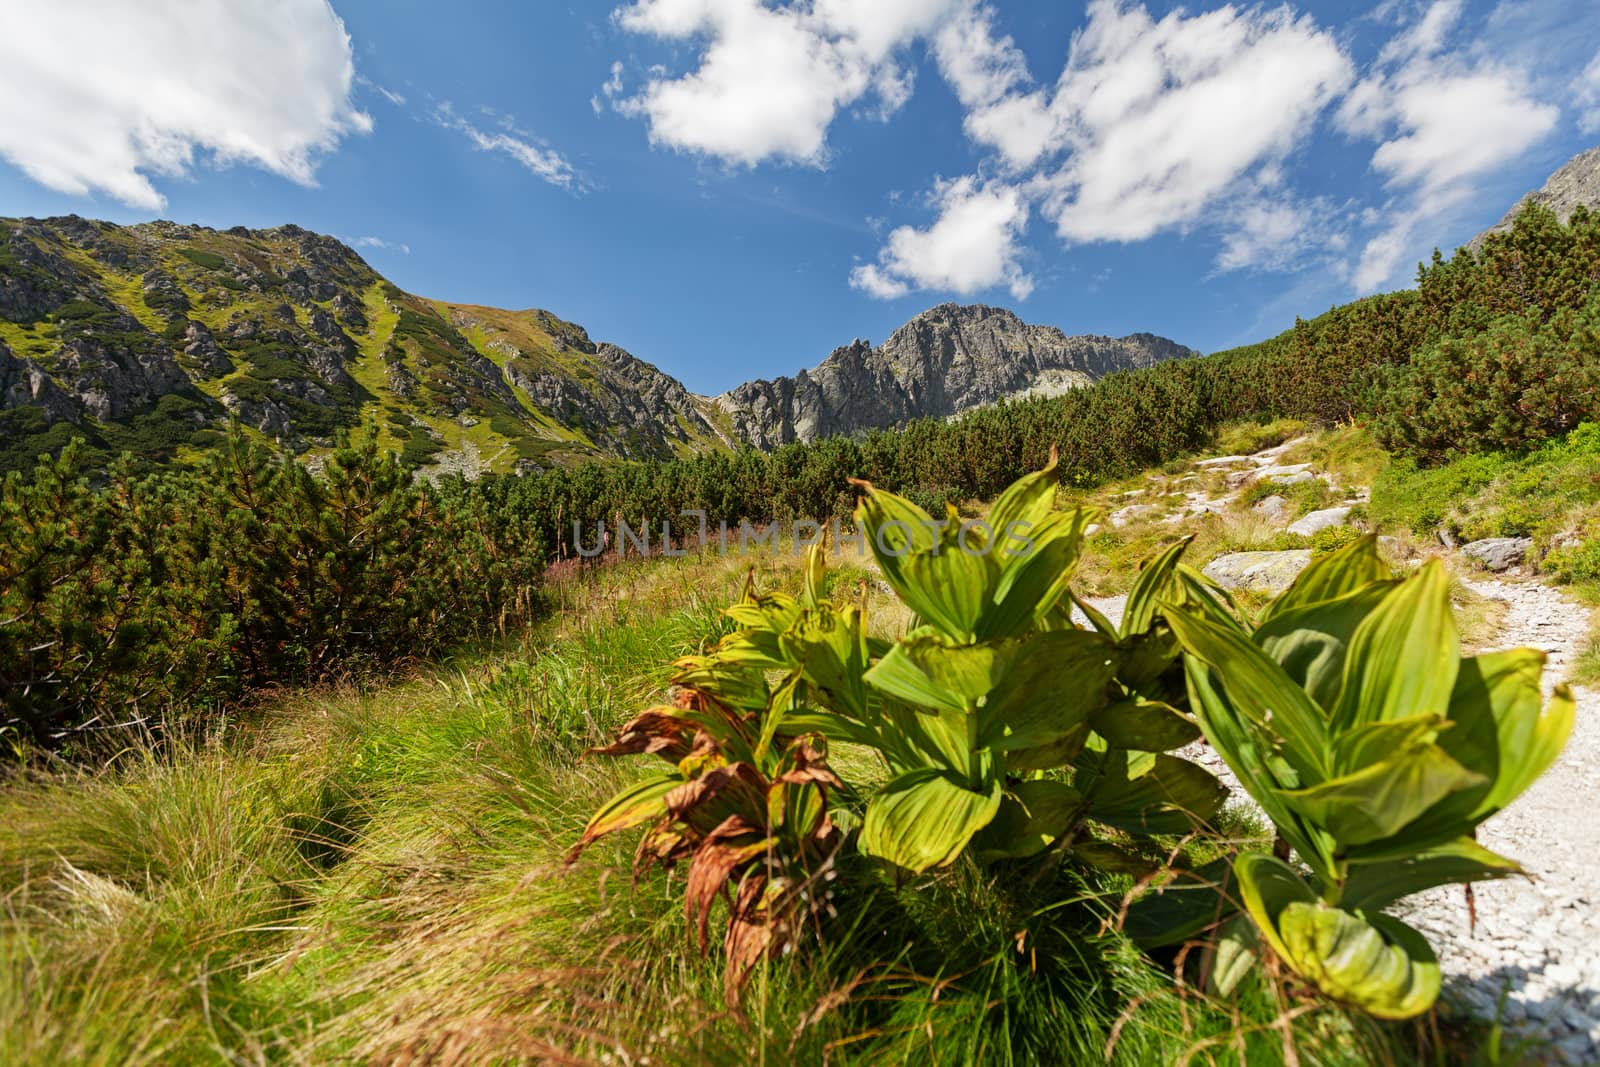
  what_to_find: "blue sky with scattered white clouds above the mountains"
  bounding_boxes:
[0,0,1600,392]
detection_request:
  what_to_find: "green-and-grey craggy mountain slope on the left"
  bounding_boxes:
[0,216,730,470]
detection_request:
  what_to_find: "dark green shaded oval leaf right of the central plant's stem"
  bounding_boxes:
[978,630,1117,755]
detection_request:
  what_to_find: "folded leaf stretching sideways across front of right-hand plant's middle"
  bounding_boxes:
[1280,741,1485,846]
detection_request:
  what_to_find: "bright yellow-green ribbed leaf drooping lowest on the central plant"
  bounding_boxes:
[859,771,1000,872]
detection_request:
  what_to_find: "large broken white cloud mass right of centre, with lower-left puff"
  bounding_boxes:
[851,0,1354,298]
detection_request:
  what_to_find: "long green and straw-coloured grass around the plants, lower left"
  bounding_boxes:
[0,555,1472,1064]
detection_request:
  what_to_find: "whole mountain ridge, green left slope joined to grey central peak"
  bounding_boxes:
[0,216,1195,474]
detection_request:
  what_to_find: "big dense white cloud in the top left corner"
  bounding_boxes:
[0,0,371,211]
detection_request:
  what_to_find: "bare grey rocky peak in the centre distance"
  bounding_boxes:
[717,304,1200,448]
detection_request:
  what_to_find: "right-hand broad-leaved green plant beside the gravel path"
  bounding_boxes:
[1165,537,1573,1019]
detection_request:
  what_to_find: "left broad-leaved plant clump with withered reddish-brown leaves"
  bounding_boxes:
[574,464,1226,997]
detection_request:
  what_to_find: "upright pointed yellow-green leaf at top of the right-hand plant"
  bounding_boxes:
[1333,560,1461,728]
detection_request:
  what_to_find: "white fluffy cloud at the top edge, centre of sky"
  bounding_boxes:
[606,0,957,166]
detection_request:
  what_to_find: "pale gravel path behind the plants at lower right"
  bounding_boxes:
[1090,579,1600,1065]
